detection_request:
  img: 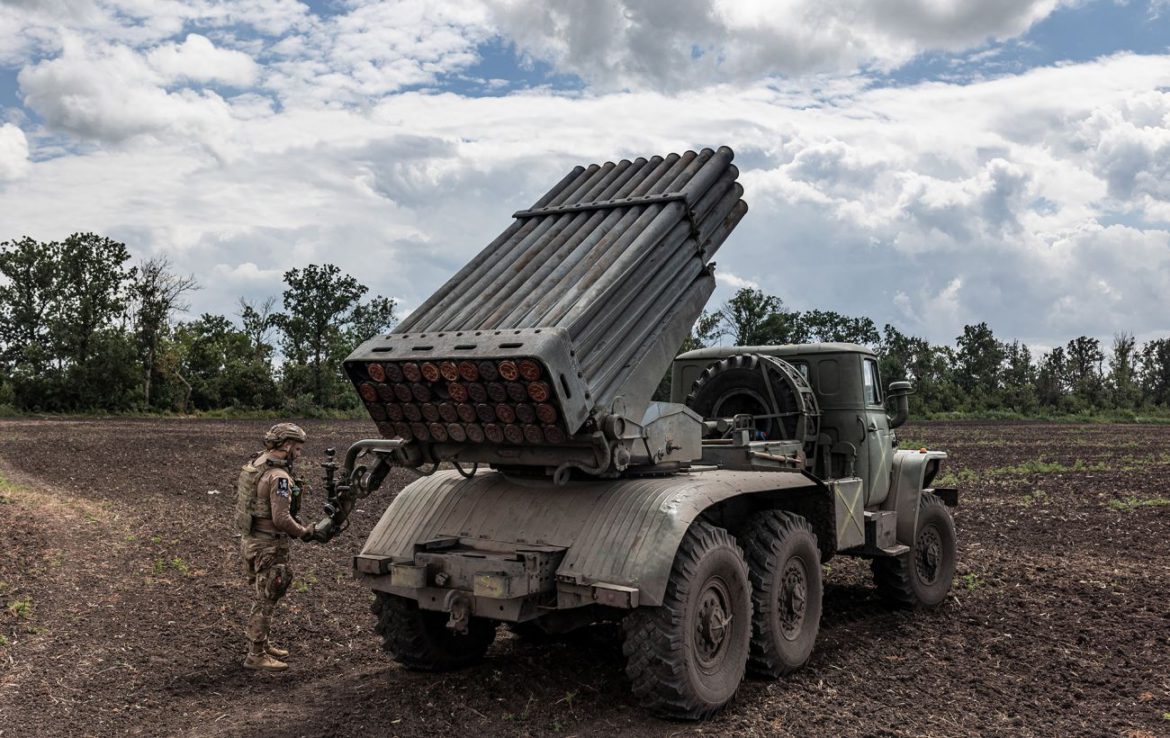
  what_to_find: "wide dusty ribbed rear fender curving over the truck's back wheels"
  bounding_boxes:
[362,470,832,605]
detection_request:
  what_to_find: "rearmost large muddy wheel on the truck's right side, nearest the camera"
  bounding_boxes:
[622,520,751,720]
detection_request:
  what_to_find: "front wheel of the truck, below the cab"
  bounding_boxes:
[873,492,957,608]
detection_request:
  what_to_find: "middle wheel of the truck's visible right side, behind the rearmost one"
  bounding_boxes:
[743,510,824,680]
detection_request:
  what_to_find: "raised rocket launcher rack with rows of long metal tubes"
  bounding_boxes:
[345,147,748,482]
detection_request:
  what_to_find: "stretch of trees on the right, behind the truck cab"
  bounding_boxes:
[678,288,1170,416]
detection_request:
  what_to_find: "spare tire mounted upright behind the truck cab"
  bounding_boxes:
[687,353,820,444]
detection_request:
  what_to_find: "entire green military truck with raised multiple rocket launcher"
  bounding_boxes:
[326,147,957,719]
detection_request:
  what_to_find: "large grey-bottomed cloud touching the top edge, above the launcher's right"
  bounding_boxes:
[487,0,1075,89]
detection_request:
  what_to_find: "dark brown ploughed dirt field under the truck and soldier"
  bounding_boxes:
[0,420,1170,738]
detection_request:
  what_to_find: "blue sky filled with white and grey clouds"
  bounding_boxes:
[0,0,1170,347]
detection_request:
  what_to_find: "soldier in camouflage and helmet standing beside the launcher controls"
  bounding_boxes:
[235,423,324,671]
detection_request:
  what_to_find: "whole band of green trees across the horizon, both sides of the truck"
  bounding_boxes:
[0,233,1170,416]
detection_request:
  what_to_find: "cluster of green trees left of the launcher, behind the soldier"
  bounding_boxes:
[0,233,395,416]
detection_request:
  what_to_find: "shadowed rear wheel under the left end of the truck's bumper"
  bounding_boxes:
[372,592,496,671]
